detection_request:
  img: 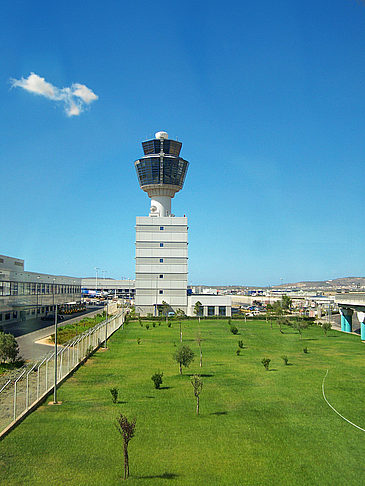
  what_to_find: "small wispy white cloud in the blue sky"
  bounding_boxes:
[11,73,99,116]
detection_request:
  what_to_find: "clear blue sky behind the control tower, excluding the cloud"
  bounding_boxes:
[0,0,365,285]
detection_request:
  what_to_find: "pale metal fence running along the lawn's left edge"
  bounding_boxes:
[0,312,125,437]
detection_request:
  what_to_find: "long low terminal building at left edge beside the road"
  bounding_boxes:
[0,255,81,330]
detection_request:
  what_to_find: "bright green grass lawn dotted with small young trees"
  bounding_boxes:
[0,320,365,486]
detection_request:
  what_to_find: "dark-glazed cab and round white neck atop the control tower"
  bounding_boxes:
[134,132,189,217]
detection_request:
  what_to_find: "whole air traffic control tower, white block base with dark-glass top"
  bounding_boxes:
[135,132,189,316]
